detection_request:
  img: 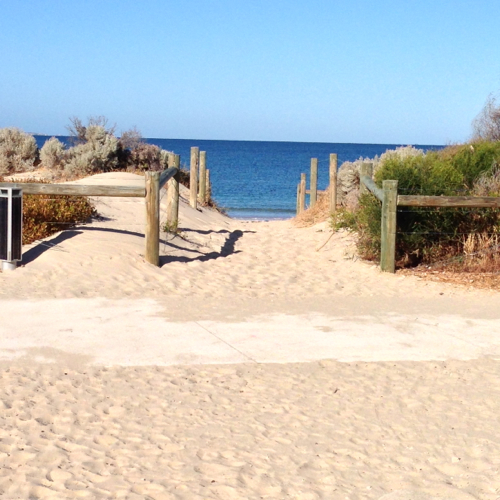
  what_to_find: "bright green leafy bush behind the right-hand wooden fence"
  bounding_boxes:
[344,143,500,266]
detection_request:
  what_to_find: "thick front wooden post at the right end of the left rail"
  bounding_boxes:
[146,172,160,266]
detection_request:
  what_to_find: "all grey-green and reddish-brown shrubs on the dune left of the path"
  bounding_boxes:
[0,116,199,244]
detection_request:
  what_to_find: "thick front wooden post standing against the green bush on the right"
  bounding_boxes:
[380,181,398,273]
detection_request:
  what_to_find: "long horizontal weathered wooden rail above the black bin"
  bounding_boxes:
[0,182,146,198]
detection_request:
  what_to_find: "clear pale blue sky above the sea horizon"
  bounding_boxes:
[0,0,500,144]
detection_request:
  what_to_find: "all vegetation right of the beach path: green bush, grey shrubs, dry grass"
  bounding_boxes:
[332,98,500,272]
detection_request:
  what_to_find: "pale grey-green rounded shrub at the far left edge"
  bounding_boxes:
[0,128,38,175]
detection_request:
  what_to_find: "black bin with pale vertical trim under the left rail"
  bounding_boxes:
[0,187,23,262]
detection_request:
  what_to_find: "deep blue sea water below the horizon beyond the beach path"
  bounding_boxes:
[35,136,443,220]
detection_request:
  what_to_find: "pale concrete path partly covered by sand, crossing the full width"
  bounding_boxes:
[0,299,500,366]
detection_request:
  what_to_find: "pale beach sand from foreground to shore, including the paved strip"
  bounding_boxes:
[0,174,500,500]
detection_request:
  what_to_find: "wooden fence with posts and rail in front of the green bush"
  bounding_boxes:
[360,163,500,273]
